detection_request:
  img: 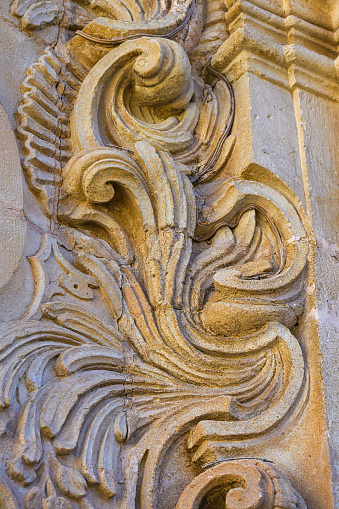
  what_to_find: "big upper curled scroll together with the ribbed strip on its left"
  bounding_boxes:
[18,29,235,216]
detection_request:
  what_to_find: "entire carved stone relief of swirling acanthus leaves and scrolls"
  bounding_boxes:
[0,1,314,509]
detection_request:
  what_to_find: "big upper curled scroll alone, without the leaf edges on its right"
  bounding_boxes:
[72,37,199,153]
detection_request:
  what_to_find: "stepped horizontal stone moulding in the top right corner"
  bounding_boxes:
[212,0,339,101]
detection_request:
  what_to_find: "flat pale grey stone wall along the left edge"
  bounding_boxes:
[0,0,59,321]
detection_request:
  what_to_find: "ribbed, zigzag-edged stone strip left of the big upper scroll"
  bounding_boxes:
[18,48,84,217]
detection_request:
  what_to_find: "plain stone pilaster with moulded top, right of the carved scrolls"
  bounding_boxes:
[202,0,339,507]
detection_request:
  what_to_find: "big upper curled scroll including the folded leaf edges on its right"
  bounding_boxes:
[68,33,234,182]
